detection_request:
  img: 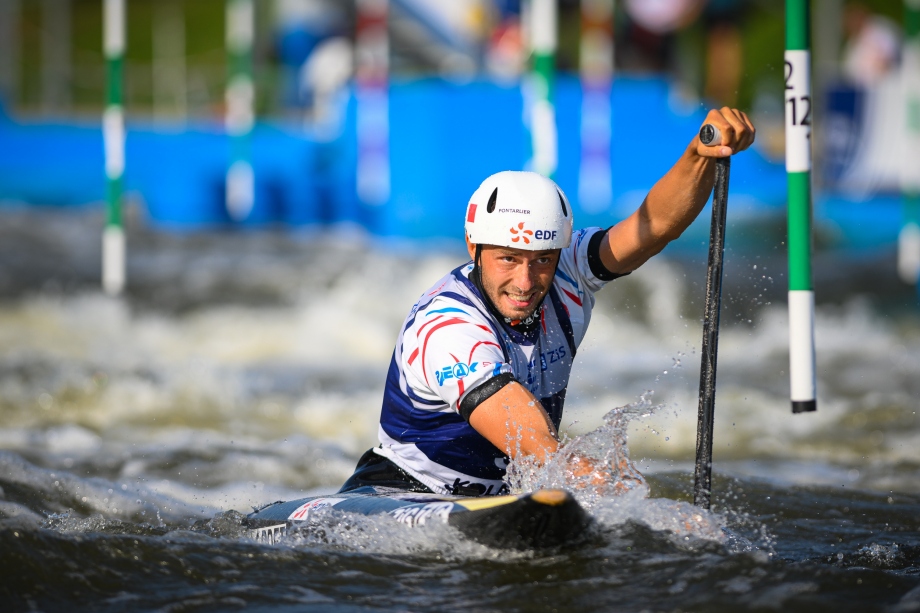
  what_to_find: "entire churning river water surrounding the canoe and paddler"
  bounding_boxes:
[0,217,920,611]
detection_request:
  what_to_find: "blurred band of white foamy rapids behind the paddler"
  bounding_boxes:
[0,225,920,540]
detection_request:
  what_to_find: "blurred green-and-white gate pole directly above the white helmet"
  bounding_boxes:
[529,0,558,177]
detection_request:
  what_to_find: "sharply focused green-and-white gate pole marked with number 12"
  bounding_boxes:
[785,0,817,413]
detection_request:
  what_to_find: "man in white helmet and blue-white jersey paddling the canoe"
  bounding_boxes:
[340,107,754,496]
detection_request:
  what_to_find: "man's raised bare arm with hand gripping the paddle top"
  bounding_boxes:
[599,107,755,274]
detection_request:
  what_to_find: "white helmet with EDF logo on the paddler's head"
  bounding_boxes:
[466,170,572,251]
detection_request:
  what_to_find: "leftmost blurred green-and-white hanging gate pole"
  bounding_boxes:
[102,0,125,296]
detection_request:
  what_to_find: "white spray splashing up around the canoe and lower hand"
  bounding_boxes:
[237,393,740,560]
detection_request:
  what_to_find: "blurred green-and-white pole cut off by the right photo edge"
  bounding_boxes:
[898,0,920,285]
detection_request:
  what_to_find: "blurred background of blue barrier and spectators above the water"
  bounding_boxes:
[0,0,903,249]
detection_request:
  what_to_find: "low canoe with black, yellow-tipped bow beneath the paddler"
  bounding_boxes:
[246,487,591,549]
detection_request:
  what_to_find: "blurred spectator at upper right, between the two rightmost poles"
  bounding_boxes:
[843,2,901,88]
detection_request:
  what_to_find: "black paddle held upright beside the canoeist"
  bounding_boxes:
[693,123,731,509]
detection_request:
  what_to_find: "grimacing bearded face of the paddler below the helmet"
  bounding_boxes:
[466,239,559,319]
